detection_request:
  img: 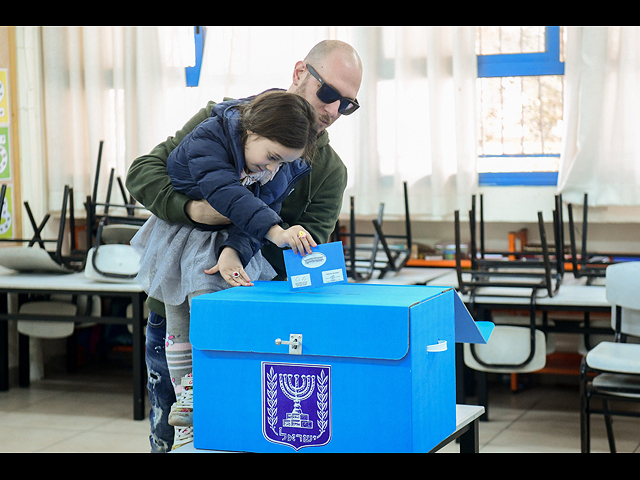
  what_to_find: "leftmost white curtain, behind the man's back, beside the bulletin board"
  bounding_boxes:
[19,27,198,215]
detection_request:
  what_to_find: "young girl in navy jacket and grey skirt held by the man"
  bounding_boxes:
[131,91,317,448]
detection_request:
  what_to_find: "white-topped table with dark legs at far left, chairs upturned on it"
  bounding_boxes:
[0,268,146,420]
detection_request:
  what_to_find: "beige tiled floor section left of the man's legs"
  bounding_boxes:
[0,364,149,452]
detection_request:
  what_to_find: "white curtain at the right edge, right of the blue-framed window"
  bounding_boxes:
[558,27,640,206]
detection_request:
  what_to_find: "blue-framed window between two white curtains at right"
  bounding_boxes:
[476,27,564,185]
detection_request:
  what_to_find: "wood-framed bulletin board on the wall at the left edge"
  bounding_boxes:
[0,27,22,240]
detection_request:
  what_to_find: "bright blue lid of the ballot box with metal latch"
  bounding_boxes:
[190,282,488,360]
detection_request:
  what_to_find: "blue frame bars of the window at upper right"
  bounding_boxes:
[477,26,564,186]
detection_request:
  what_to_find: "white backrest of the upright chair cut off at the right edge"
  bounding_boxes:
[606,262,640,337]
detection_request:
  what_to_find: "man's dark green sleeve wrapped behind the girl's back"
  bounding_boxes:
[126,102,215,225]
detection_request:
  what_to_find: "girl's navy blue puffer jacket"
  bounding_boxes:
[167,98,311,266]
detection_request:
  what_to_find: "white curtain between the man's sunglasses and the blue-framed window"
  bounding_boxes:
[350,27,477,220]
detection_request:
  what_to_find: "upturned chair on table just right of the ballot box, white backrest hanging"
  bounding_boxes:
[454,195,564,420]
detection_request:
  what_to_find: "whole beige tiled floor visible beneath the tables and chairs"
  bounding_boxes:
[0,363,640,453]
